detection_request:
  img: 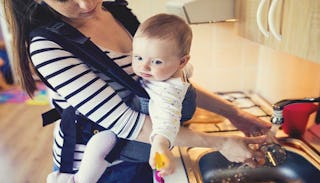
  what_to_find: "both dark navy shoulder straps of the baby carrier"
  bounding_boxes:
[30,1,149,98]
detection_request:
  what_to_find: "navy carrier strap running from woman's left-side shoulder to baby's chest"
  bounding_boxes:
[32,22,148,98]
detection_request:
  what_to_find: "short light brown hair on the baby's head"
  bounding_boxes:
[135,13,192,57]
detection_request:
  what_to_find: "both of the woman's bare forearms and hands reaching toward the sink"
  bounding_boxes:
[137,83,271,165]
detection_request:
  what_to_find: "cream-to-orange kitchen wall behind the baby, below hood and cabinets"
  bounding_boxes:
[128,0,320,103]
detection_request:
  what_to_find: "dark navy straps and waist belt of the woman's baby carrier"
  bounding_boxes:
[30,0,150,173]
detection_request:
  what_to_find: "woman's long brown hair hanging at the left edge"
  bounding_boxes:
[3,0,57,96]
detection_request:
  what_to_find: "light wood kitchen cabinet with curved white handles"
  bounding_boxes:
[236,0,320,63]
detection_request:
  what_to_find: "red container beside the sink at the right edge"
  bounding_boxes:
[282,103,318,137]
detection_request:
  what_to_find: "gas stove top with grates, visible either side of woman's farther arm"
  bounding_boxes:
[186,91,272,133]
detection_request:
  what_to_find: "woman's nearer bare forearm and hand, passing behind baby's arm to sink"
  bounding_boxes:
[136,116,266,166]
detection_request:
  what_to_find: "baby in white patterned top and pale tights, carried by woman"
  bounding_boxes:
[47,14,193,183]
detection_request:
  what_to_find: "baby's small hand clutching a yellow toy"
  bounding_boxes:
[149,135,176,177]
